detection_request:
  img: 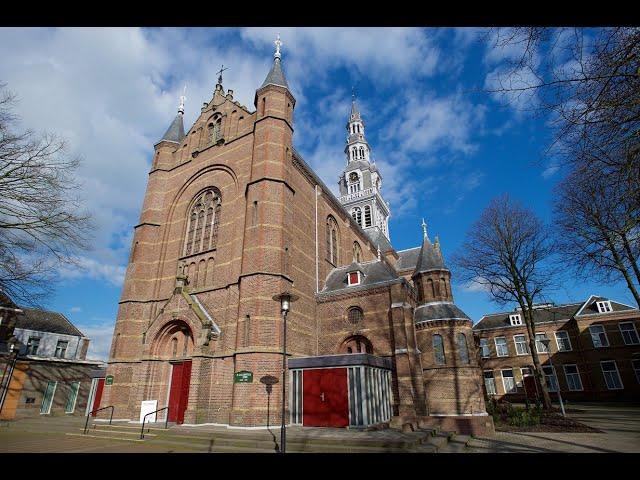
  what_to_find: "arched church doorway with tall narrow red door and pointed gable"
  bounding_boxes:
[152,320,194,423]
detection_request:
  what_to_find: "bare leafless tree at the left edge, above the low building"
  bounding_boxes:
[0,84,91,305]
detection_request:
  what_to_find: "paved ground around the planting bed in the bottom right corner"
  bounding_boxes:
[465,403,640,453]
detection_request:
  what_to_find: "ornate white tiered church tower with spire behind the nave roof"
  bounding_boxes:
[338,97,390,243]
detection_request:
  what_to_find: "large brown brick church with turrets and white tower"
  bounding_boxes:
[102,40,493,432]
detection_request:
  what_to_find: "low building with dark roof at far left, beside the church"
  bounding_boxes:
[0,293,104,420]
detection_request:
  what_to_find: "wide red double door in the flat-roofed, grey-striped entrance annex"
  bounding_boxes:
[302,368,349,427]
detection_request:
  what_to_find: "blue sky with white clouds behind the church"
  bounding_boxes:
[0,27,633,358]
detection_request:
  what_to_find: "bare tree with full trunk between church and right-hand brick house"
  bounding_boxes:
[453,194,555,409]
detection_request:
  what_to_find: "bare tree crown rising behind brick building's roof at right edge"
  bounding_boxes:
[554,166,640,307]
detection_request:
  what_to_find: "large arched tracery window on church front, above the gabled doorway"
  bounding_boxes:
[184,188,221,255]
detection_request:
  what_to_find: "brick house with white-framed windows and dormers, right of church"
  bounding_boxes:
[473,295,640,402]
